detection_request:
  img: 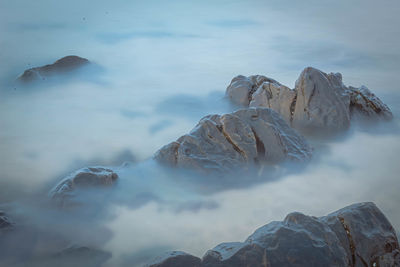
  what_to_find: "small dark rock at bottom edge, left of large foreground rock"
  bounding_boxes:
[145,251,201,267]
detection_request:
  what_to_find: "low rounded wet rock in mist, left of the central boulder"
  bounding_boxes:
[49,167,118,204]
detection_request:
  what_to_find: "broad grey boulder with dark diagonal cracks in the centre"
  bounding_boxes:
[155,108,312,174]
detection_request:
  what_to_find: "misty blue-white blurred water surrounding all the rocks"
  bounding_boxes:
[0,0,400,266]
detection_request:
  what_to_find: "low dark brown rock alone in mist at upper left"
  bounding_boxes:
[17,56,89,82]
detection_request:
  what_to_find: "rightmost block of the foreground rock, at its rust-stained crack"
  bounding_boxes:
[320,202,400,267]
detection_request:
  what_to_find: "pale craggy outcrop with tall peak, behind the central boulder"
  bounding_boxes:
[226,67,392,132]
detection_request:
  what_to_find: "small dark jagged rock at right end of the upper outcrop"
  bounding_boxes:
[348,86,393,120]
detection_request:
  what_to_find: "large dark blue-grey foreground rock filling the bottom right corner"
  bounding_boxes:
[148,202,400,267]
